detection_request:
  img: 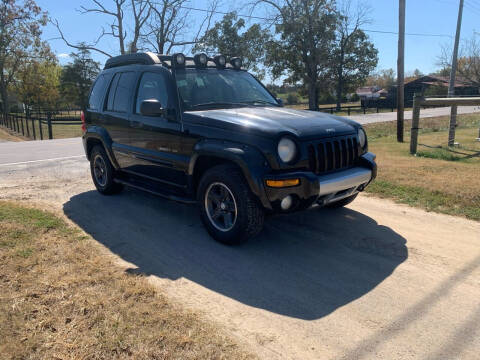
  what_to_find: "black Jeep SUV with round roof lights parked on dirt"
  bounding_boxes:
[82,53,376,244]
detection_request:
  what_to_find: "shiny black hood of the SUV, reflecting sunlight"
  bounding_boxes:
[184,107,358,139]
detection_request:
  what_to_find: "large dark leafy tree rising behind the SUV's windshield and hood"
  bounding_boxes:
[255,0,338,110]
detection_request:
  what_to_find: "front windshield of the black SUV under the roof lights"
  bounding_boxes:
[176,68,278,110]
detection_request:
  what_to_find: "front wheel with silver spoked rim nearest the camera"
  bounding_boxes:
[197,165,265,245]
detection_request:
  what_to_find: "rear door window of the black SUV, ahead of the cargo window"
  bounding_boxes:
[107,72,135,112]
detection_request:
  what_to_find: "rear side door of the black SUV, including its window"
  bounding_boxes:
[103,71,137,168]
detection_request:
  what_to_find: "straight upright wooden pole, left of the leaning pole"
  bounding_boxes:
[397,0,406,142]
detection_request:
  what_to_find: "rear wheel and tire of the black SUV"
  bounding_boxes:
[90,145,123,195]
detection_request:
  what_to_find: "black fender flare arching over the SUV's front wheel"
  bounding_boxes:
[188,140,271,209]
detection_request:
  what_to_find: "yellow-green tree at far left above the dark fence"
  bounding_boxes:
[15,59,61,111]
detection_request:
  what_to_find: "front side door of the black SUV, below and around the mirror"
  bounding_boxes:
[124,71,188,187]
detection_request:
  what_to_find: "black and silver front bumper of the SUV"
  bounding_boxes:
[264,153,377,211]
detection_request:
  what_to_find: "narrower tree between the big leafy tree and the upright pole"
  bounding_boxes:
[331,0,378,111]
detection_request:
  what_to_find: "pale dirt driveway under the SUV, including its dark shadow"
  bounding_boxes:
[0,158,480,360]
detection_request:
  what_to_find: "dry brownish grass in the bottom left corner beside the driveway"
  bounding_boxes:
[0,202,253,359]
